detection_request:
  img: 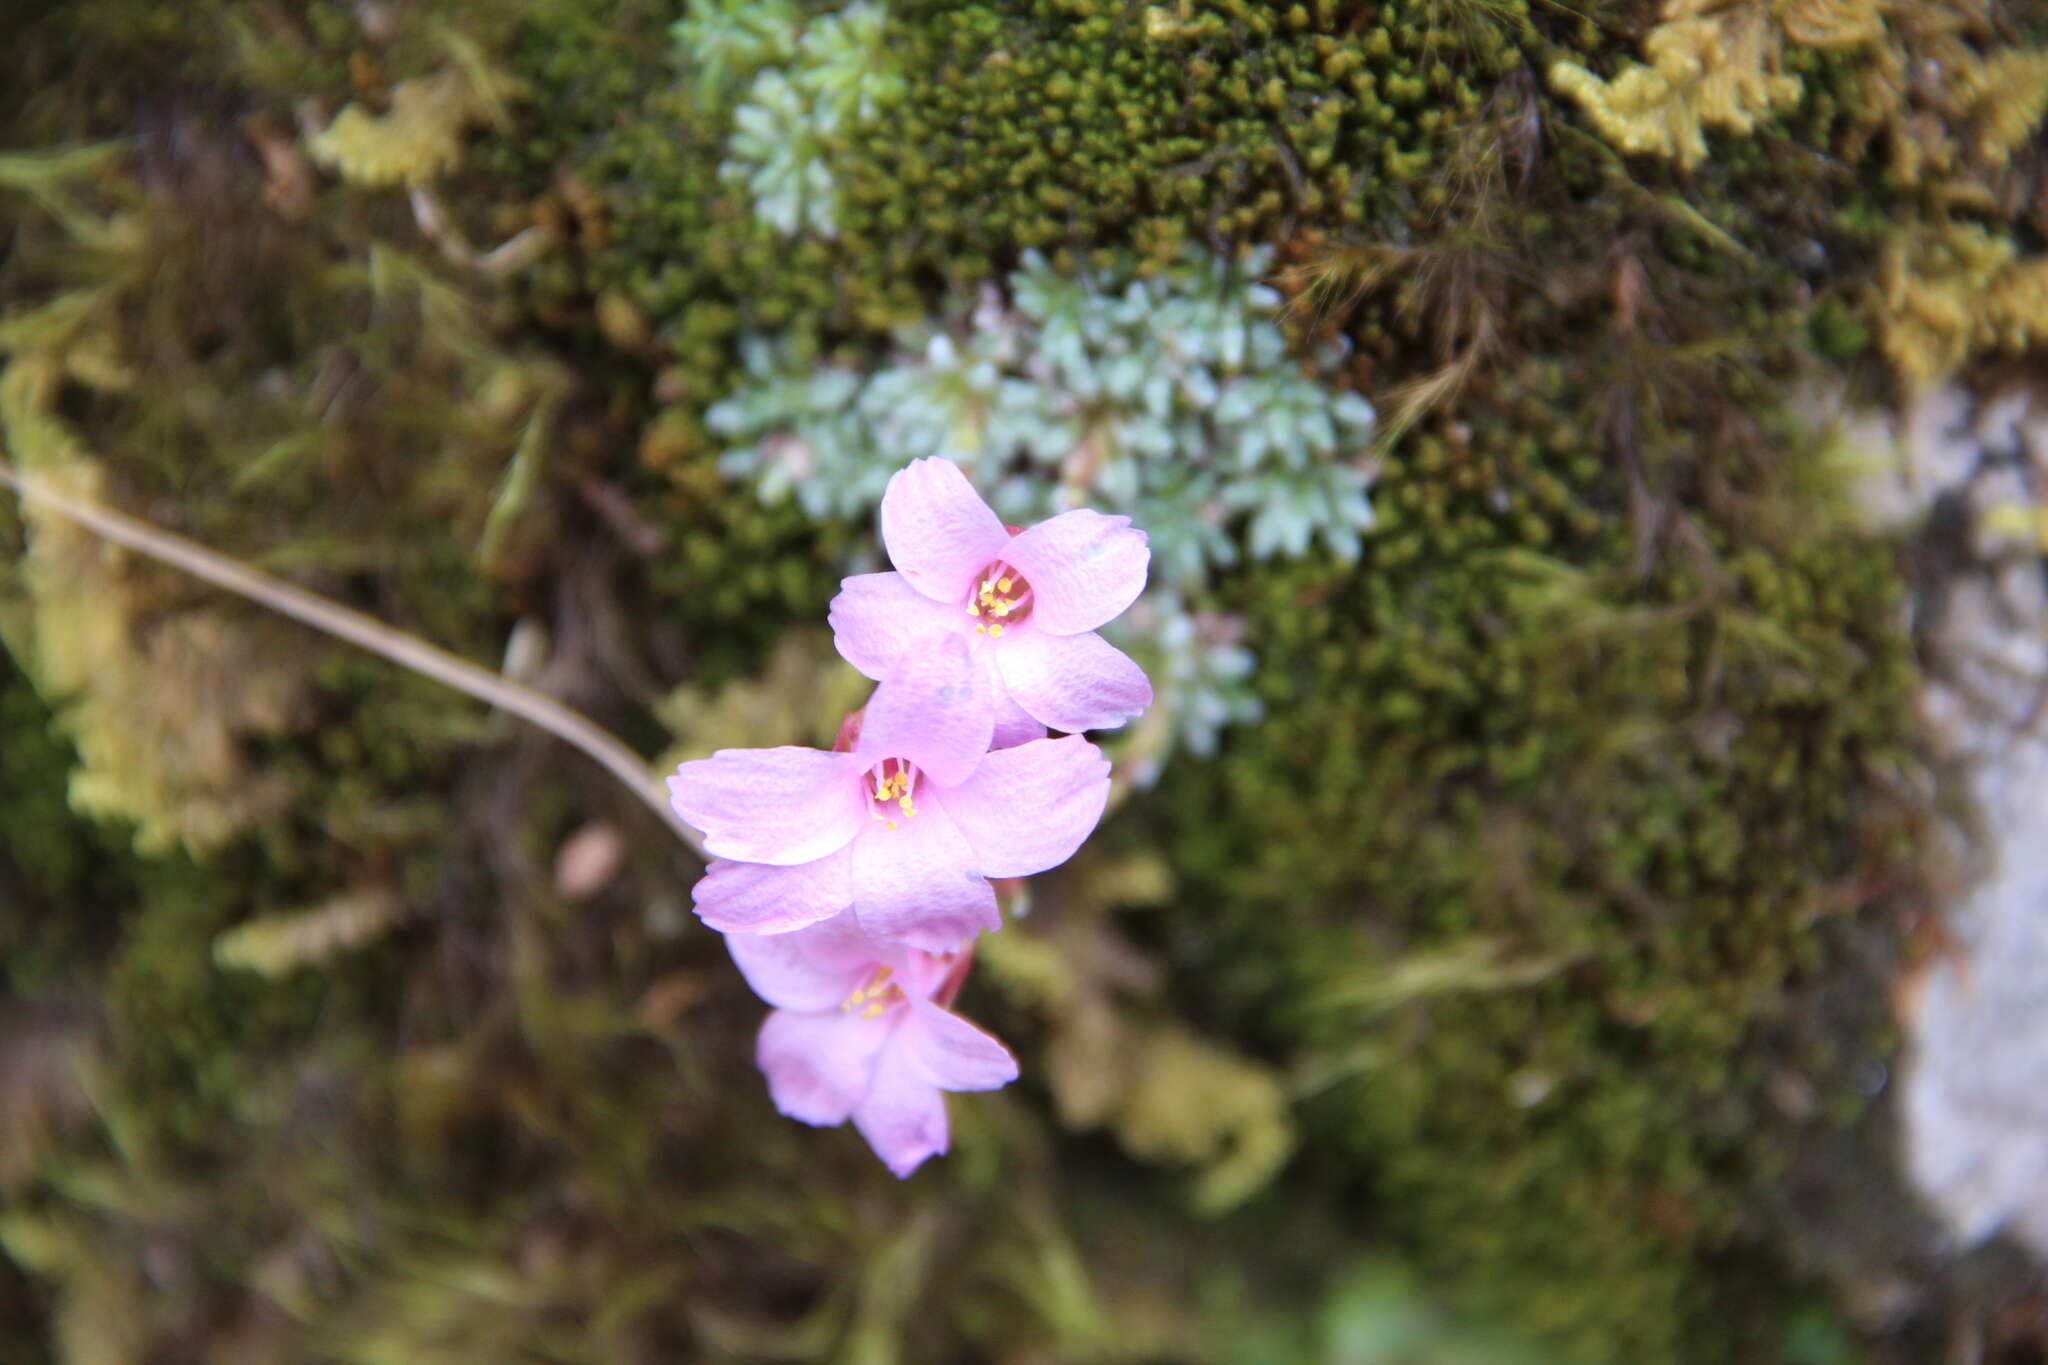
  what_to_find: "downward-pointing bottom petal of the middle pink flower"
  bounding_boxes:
[854,800,1004,954]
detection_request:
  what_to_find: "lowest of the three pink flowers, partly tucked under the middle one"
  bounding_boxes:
[725,915,1018,1177]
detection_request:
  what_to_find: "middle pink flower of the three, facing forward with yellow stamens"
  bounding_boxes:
[668,636,1110,952]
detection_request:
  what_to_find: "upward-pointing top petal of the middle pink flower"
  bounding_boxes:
[854,634,995,786]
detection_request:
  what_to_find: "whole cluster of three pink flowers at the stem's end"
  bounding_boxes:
[668,458,1151,1175]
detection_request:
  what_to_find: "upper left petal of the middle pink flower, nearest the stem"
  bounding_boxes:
[668,745,868,868]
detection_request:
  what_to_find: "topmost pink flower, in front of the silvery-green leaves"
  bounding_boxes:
[831,458,1151,747]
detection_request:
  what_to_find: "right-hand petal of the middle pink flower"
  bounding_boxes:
[944,735,1110,876]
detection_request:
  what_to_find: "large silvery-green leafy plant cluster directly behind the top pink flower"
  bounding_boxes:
[709,248,1374,769]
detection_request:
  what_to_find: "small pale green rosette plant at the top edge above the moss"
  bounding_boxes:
[670,0,903,237]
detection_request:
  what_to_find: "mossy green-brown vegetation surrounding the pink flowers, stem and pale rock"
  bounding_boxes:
[0,0,2048,1365]
